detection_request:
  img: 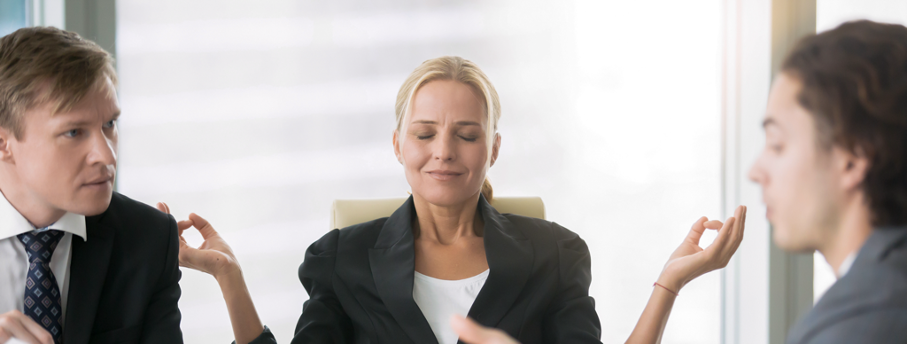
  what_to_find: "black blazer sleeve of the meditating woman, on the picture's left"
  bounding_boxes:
[291,230,353,344]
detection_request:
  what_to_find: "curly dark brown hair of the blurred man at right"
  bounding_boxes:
[782,20,908,227]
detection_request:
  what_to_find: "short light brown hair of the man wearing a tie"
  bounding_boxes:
[0,27,117,139]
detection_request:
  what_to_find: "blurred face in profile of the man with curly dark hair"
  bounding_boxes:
[749,73,842,252]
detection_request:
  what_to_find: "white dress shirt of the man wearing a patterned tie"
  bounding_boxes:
[0,194,88,325]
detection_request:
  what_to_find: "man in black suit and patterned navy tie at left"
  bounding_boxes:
[0,28,182,344]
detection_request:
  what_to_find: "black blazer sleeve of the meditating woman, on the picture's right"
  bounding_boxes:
[542,224,602,344]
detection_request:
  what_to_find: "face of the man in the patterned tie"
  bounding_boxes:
[8,79,120,216]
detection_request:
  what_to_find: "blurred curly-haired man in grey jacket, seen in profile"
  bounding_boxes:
[750,21,908,344]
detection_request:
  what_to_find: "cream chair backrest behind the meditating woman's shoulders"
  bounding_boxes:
[330,197,545,229]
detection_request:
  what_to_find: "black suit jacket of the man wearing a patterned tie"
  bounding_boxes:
[63,192,183,344]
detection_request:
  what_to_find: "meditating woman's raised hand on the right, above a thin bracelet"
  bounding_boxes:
[658,205,747,293]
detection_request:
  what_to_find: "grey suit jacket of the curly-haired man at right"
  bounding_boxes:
[788,228,908,344]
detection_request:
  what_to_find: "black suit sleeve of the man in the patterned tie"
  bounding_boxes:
[139,215,183,344]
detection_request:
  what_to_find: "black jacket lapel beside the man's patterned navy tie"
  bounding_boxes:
[63,211,115,344]
